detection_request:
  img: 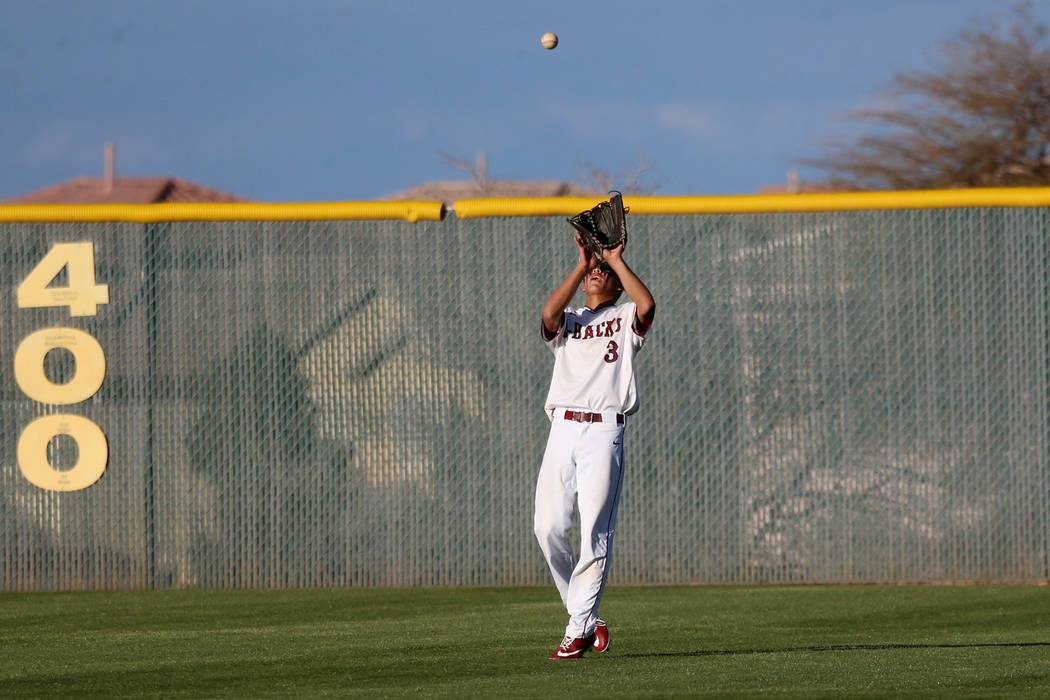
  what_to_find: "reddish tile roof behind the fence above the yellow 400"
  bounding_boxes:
[3,177,249,205]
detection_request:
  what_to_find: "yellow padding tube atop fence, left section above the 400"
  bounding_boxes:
[0,201,445,224]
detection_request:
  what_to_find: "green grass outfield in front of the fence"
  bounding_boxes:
[0,586,1050,698]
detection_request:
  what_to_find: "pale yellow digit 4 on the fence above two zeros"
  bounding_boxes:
[18,241,109,316]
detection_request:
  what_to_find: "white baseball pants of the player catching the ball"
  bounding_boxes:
[534,411,624,637]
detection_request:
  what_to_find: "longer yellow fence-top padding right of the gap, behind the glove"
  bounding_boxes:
[454,187,1050,218]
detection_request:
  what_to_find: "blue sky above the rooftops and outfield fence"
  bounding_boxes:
[0,0,1050,201]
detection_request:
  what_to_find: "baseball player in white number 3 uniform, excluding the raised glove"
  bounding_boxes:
[534,233,656,659]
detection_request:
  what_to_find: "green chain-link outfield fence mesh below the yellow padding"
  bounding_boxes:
[0,208,1050,590]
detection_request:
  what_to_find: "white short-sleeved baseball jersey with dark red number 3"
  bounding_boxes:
[544,302,645,416]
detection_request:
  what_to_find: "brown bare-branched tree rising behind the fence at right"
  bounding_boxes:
[801,2,1050,189]
